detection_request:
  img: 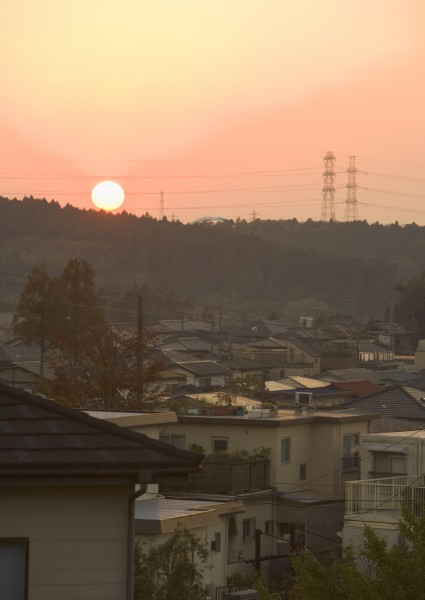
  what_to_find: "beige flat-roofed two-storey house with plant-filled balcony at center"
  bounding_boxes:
[155,407,373,571]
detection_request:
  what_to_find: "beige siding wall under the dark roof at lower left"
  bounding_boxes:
[0,486,132,600]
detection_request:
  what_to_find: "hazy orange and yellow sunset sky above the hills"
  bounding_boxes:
[0,0,425,225]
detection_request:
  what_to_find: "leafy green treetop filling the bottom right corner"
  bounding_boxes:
[292,509,425,600]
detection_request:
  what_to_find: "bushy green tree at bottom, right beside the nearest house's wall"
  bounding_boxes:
[134,527,208,600]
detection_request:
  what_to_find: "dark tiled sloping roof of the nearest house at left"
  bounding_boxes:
[0,386,200,484]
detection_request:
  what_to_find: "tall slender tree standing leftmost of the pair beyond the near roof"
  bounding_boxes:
[13,266,52,377]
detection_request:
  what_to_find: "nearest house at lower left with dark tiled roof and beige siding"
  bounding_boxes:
[0,386,200,600]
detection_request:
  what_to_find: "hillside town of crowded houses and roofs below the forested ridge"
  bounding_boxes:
[0,296,425,600]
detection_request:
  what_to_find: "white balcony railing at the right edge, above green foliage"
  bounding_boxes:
[345,475,425,518]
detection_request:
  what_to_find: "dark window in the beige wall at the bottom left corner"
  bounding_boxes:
[0,538,28,600]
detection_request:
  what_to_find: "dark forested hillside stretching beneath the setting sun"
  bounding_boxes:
[0,198,425,317]
